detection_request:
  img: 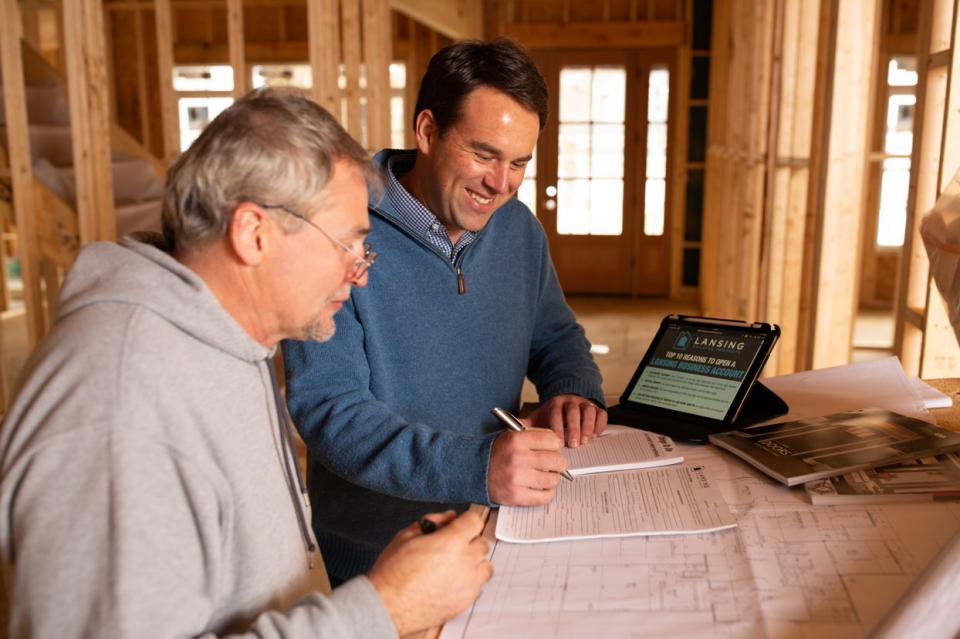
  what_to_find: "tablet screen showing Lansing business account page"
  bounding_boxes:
[627,322,767,420]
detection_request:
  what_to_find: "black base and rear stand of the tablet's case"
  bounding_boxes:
[607,382,790,443]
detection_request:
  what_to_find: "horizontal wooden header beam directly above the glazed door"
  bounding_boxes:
[503,20,684,49]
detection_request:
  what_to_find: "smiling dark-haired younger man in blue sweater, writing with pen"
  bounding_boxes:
[284,40,606,579]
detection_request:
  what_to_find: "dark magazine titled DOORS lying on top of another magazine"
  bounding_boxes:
[710,408,960,486]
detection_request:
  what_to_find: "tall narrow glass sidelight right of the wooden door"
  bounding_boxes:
[643,67,670,236]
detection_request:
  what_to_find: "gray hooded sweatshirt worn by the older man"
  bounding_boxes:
[0,240,395,639]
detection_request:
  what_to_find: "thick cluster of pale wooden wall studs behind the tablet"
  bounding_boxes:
[701,0,880,374]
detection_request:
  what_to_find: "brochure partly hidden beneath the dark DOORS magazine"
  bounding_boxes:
[806,453,960,505]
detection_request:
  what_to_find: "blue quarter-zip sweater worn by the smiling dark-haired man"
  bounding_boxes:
[283,152,603,579]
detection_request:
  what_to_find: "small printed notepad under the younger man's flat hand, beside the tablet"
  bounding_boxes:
[561,425,683,476]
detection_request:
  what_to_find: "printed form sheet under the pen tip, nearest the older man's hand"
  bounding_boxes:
[497,465,737,543]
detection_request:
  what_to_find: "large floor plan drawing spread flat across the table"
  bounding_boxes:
[442,447,960,639]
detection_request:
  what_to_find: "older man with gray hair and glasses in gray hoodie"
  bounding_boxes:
[0,90,491,638]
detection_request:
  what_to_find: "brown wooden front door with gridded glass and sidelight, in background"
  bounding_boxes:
[525,50,674,296]
